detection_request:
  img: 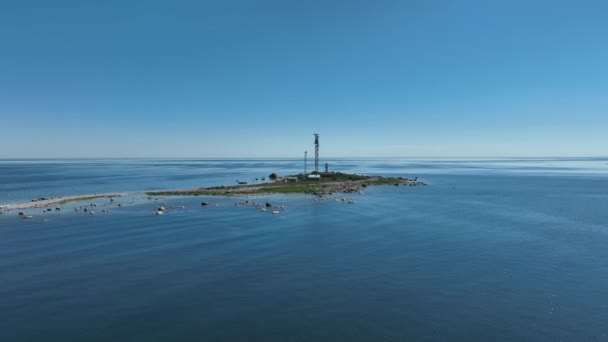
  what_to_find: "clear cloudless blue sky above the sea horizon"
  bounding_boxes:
[0,0,608,158]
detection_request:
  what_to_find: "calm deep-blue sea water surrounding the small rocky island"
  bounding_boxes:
[0,158,608,341]
